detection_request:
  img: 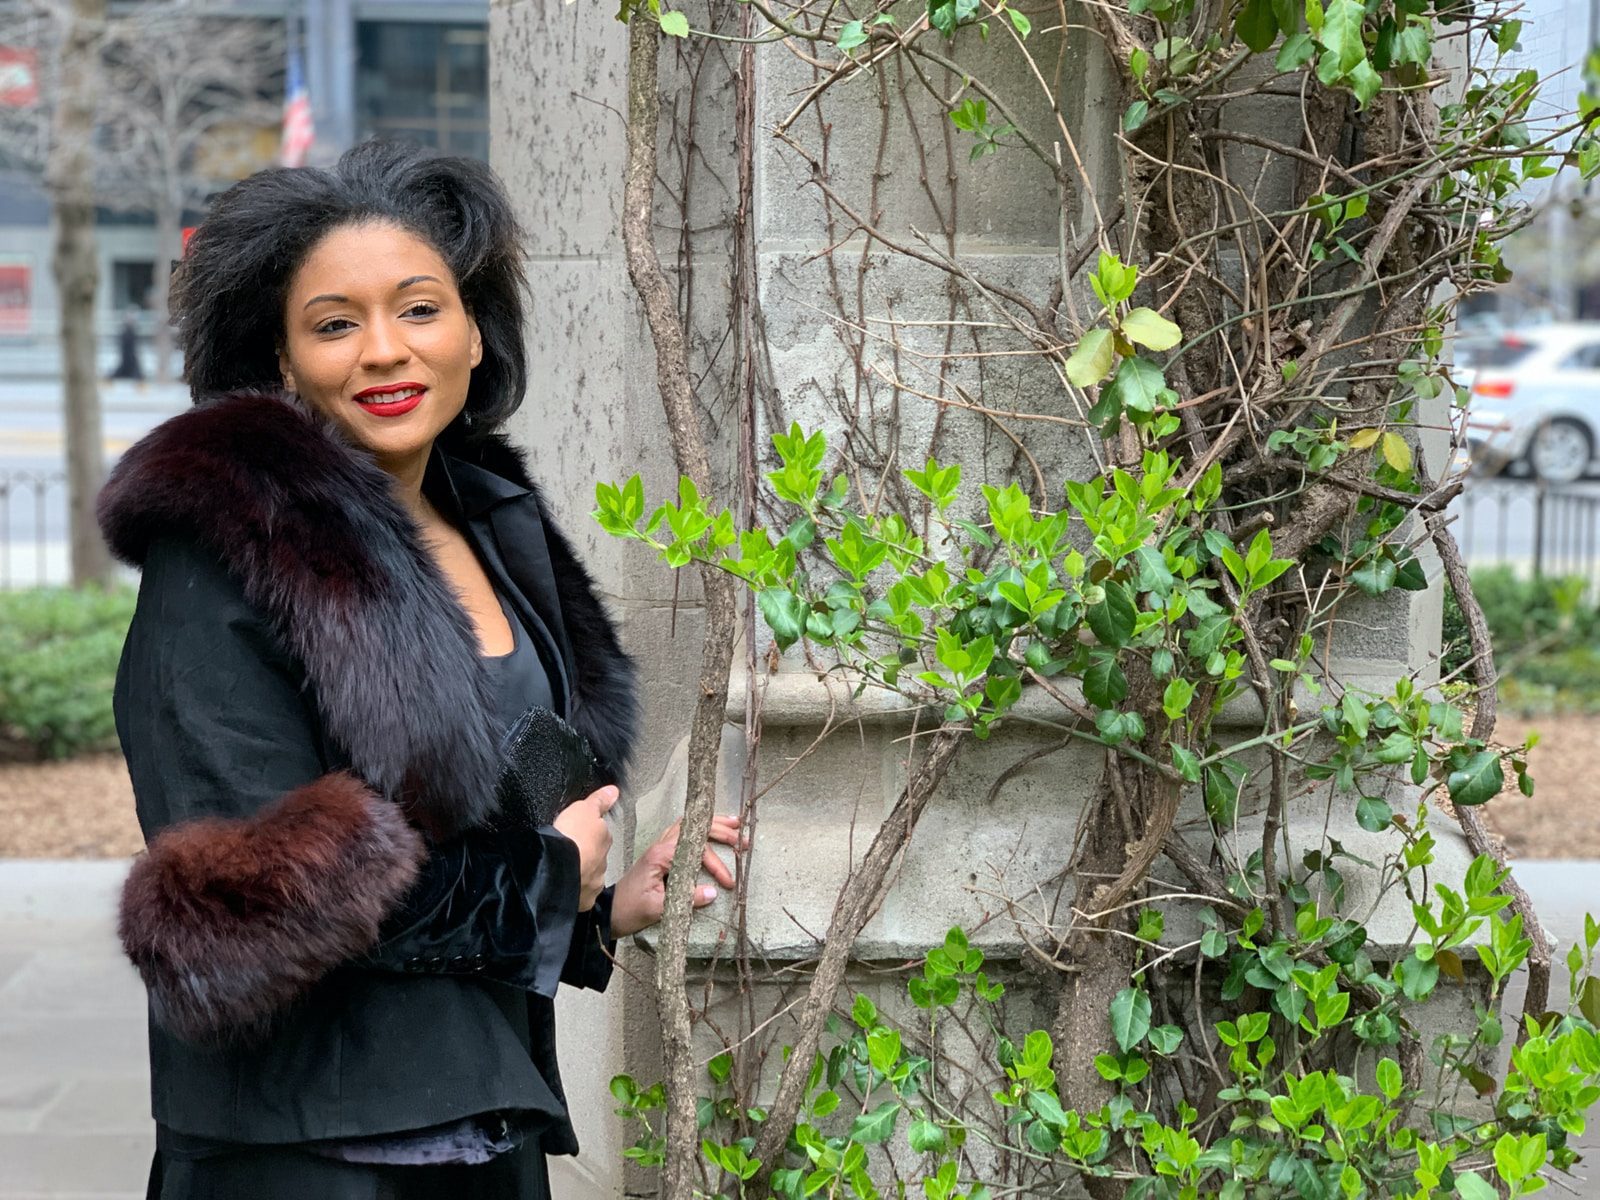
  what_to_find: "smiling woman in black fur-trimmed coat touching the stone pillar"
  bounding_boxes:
[101,144,738,1200]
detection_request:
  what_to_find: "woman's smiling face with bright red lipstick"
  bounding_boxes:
[278,222,483,474]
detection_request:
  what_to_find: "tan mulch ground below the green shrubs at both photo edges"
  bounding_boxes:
[0,714,1600,859]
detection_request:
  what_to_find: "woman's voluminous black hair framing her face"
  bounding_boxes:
[171,141,528,437]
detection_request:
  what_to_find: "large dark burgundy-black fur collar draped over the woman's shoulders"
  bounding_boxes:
[99,394,638,834]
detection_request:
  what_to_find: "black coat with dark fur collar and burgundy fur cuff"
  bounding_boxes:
[99,394,637,1154]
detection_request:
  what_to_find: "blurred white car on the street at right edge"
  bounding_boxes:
[1456,322,1600,483]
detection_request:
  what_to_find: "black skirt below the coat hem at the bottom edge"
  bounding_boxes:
[146,1144,550,1200]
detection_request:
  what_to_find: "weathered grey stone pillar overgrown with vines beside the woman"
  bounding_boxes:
[490,0,1466,1200]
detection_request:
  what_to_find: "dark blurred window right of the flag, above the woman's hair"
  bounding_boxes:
[355,21,490,158]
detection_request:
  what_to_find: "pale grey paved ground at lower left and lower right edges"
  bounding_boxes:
[0,859,1600,1200]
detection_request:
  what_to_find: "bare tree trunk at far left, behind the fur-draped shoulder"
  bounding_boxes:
[45,0,110,587]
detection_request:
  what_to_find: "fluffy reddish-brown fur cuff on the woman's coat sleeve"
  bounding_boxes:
[118,771,426,1042]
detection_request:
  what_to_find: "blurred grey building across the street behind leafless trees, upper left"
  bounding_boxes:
[0,0,490,379]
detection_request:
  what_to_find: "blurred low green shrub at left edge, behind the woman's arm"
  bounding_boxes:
[0,587,134,758]
